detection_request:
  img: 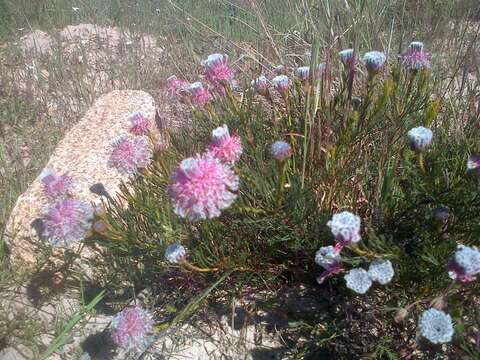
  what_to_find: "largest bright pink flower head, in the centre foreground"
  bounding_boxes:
[168,153,239,221]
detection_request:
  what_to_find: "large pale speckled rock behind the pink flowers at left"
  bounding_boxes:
[6,90,155,264]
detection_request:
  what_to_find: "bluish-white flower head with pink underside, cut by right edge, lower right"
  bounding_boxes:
[448,245,480,282]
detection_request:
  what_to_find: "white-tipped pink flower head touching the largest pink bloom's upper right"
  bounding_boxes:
[208,125,243,165]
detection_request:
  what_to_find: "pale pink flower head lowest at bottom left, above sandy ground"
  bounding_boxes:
[110,306,153,352]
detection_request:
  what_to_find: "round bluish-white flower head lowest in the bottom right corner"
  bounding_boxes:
[418,309,453,344]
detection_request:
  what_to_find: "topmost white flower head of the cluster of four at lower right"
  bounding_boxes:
[327,211,362,246]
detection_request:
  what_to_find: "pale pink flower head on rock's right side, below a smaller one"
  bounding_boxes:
[109,136,152,175]
